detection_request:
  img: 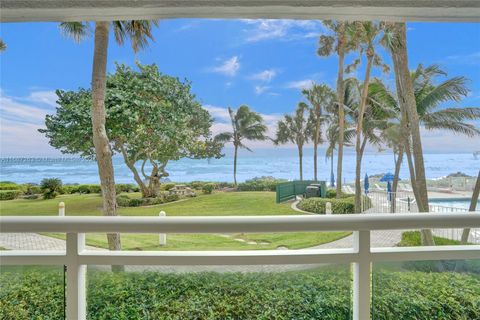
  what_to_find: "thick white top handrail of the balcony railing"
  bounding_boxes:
[0,211,480,233]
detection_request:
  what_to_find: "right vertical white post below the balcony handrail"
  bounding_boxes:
[353,231,371,320]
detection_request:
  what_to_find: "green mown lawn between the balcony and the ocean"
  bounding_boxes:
[0,192,349,250]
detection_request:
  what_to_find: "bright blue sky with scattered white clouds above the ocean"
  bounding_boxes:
[0,19,480,156]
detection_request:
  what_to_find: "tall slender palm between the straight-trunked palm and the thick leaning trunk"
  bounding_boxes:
[347,22,388,213]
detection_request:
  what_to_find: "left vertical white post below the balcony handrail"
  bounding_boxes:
[66,233,87,320]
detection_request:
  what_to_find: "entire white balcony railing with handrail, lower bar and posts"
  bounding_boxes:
[0,212,480,320]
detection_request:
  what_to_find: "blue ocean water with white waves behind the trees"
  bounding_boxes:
[0,149,480,184]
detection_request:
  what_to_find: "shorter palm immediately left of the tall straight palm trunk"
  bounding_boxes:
[302,84,335,181]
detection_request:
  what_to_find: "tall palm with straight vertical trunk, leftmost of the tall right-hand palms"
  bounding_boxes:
[317,20,350,198]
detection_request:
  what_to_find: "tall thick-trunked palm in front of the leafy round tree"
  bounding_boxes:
[60,20,157,255]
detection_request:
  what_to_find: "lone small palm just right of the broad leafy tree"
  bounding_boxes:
[215,105,267,185]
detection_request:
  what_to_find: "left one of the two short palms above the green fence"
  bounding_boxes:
[274,102,314,180]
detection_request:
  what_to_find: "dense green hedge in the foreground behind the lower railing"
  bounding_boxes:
[0,268,480,320]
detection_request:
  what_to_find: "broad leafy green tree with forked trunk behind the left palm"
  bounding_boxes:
[39,64,221,197]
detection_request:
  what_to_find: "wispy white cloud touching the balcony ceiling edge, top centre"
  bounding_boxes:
[242,19,323,42]
